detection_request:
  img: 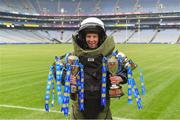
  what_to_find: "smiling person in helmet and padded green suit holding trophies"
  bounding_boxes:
[71,17,127,119]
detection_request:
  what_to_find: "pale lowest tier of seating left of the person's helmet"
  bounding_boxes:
[0,29,74,44]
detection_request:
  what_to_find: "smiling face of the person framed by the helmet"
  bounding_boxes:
[86,33,99,49]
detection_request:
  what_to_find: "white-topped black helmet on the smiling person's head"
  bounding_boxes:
[77,17,106,48]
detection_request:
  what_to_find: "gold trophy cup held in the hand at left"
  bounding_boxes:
[68,55,79,94]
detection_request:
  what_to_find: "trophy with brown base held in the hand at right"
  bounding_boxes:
[107,56,124,98]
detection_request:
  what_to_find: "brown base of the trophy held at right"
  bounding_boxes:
[109,88,124,98]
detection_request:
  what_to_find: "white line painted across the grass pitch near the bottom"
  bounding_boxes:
[0,104,130,120]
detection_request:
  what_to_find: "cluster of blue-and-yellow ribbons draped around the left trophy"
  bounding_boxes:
[45,53,84,116]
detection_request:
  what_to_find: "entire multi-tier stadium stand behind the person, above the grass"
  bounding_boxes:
[0,0,180,44]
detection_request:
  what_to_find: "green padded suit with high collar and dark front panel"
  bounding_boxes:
[71,36,115,119]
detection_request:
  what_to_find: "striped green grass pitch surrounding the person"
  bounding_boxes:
[0,44,180,119]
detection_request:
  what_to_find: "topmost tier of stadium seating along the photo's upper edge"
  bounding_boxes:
[0,0,180,14]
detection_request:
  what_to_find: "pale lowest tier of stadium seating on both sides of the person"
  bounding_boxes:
[0,29,180,44]
